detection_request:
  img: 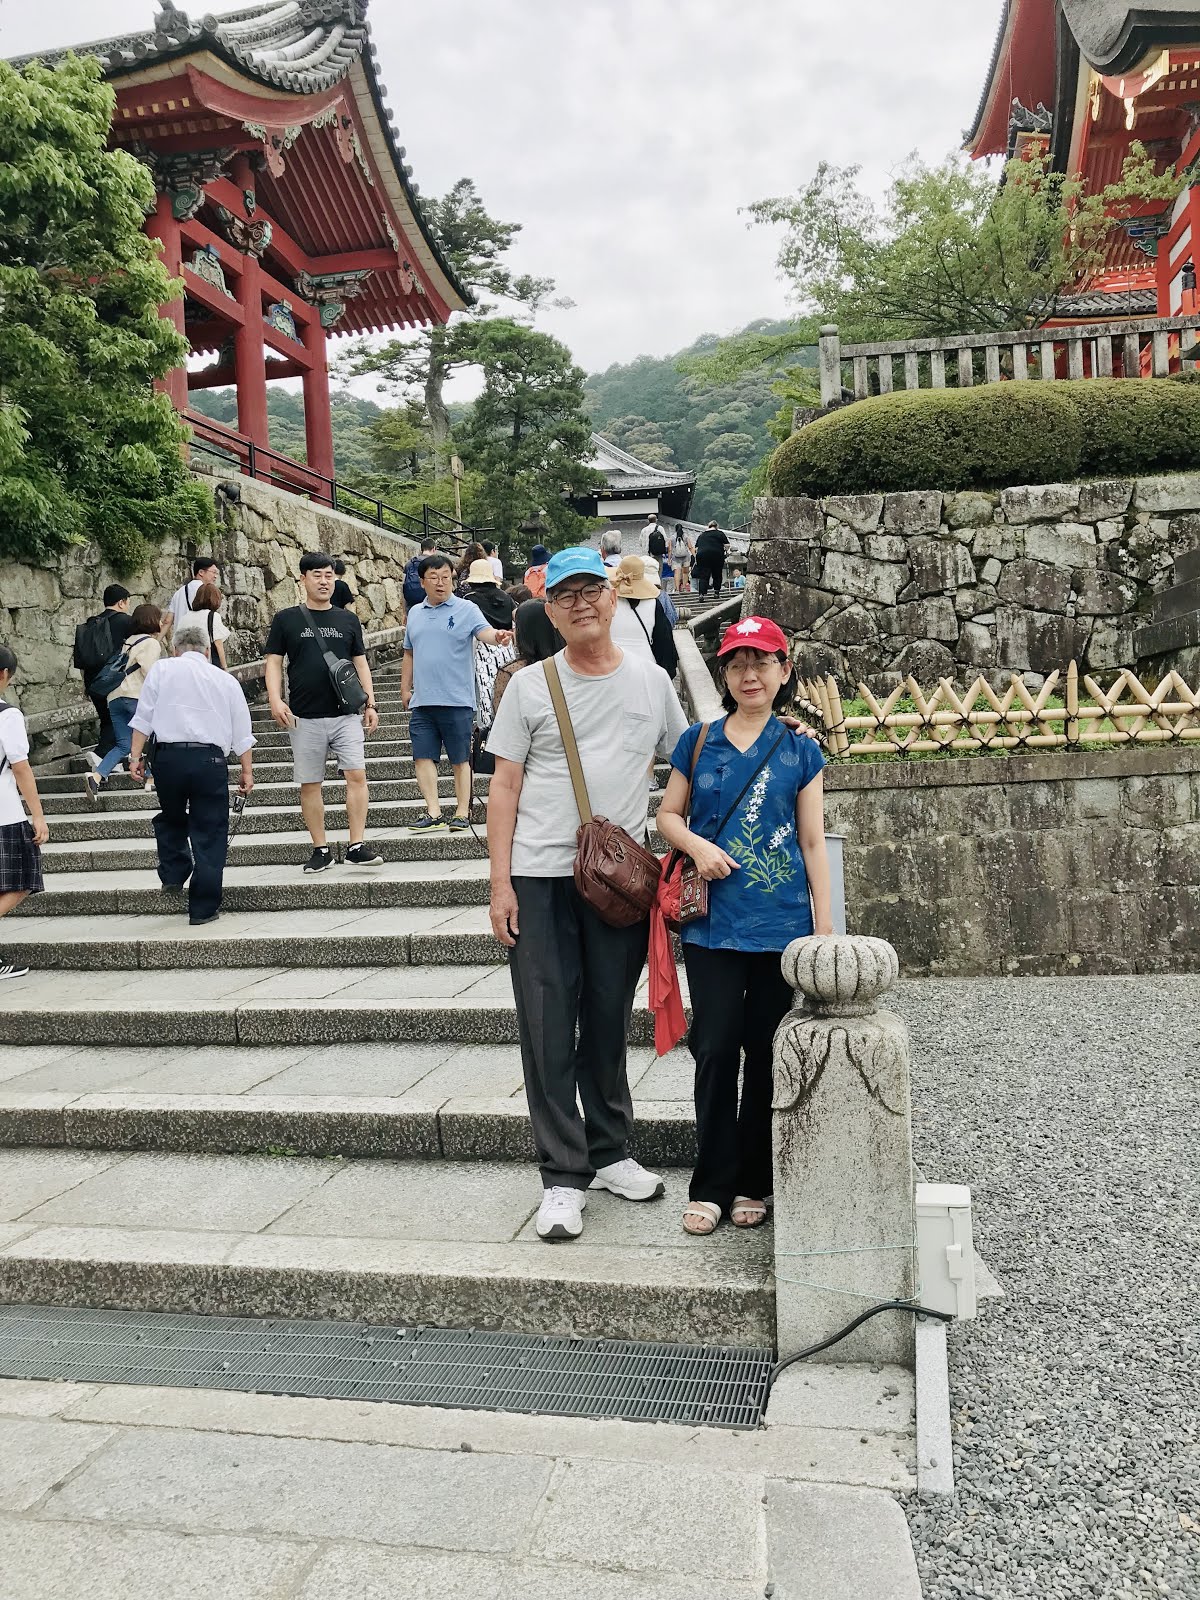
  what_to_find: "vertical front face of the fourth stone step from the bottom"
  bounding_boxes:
[3,934,507,966]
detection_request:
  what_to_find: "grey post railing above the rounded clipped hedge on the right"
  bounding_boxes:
[812,314,1200,409]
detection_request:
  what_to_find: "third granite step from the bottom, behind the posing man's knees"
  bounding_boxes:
[3,963,686,1046]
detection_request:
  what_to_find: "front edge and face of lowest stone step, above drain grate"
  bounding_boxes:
[0,1228,774,1347]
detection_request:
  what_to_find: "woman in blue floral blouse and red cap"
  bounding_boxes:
[658,616,834,1234]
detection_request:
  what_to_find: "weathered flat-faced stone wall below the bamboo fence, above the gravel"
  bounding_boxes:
[826,747,1200,976]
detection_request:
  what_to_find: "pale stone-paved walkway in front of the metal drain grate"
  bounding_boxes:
[0,1368,920,1600]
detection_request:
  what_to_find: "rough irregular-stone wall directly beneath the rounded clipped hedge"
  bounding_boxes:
[746,474,1200,691]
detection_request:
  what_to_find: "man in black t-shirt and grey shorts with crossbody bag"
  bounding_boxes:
[266,552,384,872]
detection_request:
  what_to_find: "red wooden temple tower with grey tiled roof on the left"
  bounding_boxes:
[12,0,466,488]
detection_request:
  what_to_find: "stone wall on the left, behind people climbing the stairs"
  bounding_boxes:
[0,472,418,712]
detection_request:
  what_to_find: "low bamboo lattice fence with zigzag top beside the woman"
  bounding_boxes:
[797,661,1200,757]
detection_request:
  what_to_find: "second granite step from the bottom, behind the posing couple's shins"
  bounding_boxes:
[0,1043,696,1168]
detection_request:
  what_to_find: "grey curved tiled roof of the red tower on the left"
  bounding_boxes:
[13,0,472,302]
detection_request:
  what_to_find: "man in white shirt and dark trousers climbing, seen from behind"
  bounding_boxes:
[130,619,254,928]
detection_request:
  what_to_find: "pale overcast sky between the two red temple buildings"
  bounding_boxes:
[0,0,1002,371]
